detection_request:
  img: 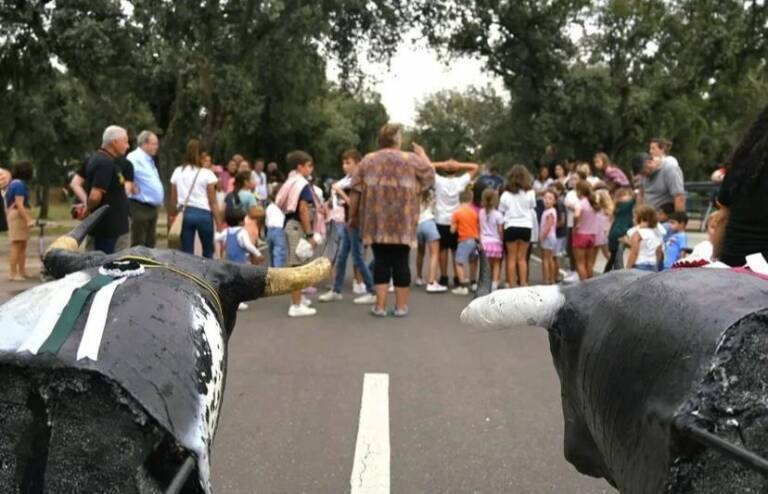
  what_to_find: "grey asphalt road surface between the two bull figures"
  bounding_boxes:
[213,272,615,494]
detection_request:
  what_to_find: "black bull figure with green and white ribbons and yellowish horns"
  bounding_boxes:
[0,206,335,493]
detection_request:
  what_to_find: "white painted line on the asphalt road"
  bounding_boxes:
[349,373,389,494]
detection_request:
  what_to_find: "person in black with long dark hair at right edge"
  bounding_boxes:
[712,107,768,266]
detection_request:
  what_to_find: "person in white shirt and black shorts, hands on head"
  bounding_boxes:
[432,160,480,286]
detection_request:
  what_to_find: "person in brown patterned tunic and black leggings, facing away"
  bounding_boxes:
[349,124,435,317]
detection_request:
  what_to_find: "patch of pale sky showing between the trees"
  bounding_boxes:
[328,38,504,126]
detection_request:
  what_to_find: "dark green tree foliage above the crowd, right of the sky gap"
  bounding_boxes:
[422,0,768,179]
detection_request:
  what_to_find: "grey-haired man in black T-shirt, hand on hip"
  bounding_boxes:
[78,125,133,254]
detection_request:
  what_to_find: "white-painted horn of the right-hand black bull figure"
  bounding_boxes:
[461,285,565,329]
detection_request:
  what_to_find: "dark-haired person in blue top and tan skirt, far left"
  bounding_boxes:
[5,161,35,281]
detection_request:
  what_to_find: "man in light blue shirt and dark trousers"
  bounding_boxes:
[127,130,165,248]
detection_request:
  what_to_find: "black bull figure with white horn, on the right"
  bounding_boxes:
[461,269,768,494]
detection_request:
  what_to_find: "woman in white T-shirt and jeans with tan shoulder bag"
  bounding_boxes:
[168,139,221,259]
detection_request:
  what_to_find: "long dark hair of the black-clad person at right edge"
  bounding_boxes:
[726,106,768,196]
